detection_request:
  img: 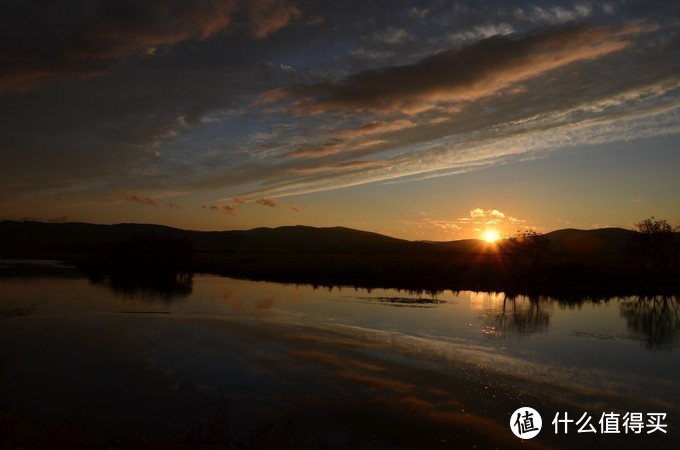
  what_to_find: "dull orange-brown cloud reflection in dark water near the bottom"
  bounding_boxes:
[282,340,549,449]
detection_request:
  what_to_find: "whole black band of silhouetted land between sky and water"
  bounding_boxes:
[0,217,680,295]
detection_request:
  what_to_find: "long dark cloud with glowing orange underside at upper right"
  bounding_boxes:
[262,26,645,114]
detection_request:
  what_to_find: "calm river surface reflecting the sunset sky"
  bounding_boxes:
[0,275,680,448]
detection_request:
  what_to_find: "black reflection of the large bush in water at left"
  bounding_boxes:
[90,273,193,303]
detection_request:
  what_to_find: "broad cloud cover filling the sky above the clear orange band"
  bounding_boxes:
[0,0,680,220]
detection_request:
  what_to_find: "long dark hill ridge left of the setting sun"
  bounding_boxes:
[0,221,439,255]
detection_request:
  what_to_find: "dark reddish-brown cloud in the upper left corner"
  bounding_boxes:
[0,0,300,92]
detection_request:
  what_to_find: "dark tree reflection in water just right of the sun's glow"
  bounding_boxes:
[494,296,550,336]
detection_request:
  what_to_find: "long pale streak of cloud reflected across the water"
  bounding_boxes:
[282,324,680,410]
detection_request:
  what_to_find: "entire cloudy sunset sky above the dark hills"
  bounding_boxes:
[0,0,680,240]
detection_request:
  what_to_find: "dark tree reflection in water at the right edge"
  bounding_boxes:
[619,295,680,350]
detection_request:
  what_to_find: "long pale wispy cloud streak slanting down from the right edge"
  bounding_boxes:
[227,89,680,202]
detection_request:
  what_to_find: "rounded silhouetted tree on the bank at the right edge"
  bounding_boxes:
[628,216,679,274]
